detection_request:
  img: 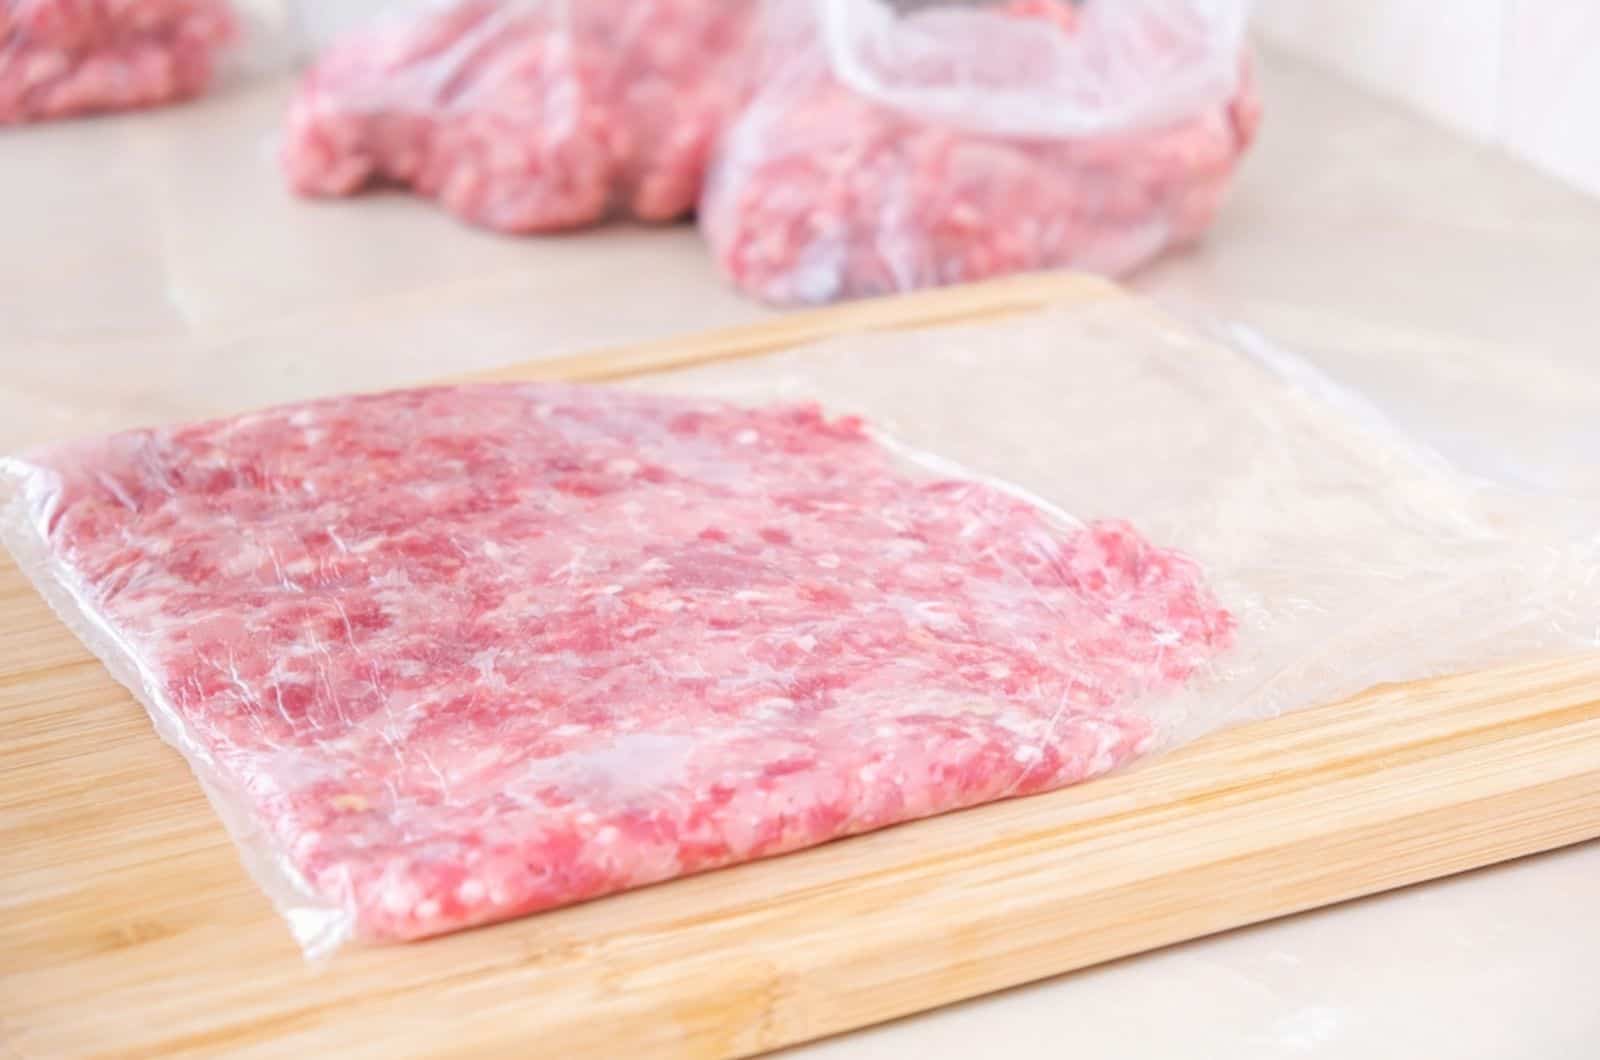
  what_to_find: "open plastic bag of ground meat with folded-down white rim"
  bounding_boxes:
[701,0,1259,303]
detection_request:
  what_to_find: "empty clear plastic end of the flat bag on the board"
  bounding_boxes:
[630,298,1600,745]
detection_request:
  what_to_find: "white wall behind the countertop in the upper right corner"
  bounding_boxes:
[1258,0,1600,195]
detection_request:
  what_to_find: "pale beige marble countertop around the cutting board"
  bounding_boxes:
[0,41,1600,1060]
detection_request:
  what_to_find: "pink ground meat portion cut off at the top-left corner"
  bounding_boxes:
[0,0,237,125]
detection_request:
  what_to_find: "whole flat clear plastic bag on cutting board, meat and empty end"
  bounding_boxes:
[0,303,1600,953]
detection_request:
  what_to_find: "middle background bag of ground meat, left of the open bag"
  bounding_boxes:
[283,0,754,232]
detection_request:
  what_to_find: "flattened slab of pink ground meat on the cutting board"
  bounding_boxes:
[12,384,1234,940]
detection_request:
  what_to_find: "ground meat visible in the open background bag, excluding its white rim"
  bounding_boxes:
[701,0,1261,303]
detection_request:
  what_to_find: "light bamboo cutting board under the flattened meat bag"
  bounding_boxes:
[0,277,1600,1060]
